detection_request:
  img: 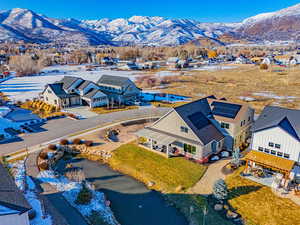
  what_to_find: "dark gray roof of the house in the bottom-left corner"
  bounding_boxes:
[0,164,32,213]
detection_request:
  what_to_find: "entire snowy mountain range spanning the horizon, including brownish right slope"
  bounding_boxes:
[0,4,300,46]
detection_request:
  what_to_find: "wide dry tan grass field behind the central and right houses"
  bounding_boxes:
[161,65,300,112]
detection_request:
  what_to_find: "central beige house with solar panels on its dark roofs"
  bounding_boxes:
[137,96,253,162]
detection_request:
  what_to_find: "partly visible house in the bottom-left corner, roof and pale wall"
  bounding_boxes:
[0,164,31,225]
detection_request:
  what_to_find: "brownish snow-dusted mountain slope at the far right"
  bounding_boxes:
[235,4,300,41]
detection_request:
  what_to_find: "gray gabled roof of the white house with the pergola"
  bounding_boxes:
[252,106,300,140]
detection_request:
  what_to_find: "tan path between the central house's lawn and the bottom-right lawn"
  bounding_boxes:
[189,159,230,195]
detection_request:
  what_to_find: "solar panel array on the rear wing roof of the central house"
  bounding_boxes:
[212,102,241,119]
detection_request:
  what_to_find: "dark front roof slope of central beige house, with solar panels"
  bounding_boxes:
[174,98,224,145]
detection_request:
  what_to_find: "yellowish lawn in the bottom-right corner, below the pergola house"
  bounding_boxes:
[226,168,300,225]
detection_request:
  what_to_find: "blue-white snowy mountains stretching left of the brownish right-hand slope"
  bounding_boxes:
[0,9,236,46]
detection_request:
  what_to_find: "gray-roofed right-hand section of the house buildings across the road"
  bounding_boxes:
[97,75,141,105]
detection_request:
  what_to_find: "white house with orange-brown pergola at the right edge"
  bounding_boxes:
[246,106,300,183]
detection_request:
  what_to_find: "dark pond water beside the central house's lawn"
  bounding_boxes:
[58,159,188,225]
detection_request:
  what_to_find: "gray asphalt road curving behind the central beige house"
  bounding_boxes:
[0,107,170,154]
